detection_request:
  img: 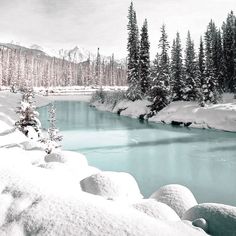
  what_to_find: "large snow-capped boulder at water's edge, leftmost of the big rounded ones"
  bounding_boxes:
[80,171,143,199]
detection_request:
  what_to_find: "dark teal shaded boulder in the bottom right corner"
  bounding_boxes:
[182,203,236,236]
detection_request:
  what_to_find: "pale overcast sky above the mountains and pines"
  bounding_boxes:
[0,0,236,58]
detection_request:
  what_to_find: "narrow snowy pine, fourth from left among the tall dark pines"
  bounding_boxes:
[170,32,185,101]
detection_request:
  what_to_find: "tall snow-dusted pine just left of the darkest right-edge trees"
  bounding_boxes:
[202,21,221,103]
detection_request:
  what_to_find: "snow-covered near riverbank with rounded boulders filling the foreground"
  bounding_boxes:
[0,92,236,236]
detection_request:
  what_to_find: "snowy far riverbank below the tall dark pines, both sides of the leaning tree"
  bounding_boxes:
[93,94,236,132]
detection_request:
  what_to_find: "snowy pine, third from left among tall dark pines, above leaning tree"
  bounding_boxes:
[150,25,171,115]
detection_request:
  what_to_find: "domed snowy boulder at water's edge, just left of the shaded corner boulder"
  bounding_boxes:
[150,184,197,218]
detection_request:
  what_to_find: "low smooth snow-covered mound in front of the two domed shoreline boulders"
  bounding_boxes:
[132,199,180,221]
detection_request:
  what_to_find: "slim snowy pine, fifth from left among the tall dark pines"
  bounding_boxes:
[183,31,200,101]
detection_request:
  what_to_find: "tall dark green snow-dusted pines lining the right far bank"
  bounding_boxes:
[127,3,236,113]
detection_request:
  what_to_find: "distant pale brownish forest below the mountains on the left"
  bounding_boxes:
[0,45,126,88]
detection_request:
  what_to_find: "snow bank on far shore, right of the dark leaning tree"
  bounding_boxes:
[149,102,236,132]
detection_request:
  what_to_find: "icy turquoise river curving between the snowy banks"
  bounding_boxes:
[38,101,236,206]
